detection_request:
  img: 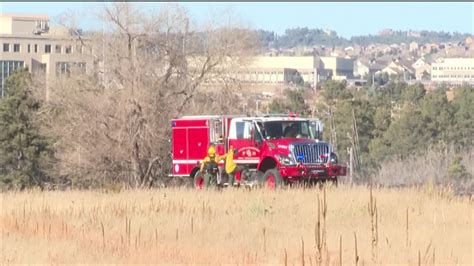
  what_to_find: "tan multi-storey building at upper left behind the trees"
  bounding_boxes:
[0,14,93,98]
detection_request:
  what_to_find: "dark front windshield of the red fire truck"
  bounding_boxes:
[257,121,314,139]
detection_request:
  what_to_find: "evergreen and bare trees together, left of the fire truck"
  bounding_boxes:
[0,3,256,188]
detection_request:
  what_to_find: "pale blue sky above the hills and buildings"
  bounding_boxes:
[0,3,474,37]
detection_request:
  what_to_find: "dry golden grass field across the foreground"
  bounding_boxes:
[0,185,474,265]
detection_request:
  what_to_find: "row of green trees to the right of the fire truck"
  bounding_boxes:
[269,81,474,182]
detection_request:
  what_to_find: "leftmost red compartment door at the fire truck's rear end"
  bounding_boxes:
[172,127,188,176]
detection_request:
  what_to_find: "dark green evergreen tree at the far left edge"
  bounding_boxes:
[0,69,52,189]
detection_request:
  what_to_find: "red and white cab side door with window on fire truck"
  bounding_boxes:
[229,119,261,164]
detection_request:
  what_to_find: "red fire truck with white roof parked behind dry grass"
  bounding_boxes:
[171,115,346,188]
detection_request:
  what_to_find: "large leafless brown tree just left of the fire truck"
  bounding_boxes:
[44,3,256,187]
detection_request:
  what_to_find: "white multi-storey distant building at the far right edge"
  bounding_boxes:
[431,58,474,86]
